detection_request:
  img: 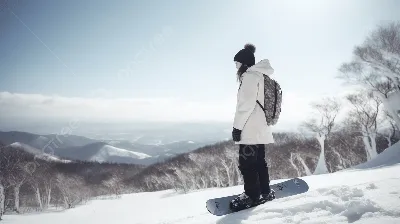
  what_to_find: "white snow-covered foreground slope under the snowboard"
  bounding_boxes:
[3,142,400,224]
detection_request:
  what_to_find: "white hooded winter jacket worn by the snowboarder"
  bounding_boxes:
[233,59,274,145]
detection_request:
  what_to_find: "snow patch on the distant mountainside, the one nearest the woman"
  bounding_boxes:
[90,145,151,162]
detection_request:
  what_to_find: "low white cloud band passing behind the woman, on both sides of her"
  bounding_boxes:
[0,92,350,130]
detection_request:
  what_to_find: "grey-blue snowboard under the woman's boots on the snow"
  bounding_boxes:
[206,178,308,216]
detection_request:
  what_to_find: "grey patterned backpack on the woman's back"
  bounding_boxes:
[257,75,282,126]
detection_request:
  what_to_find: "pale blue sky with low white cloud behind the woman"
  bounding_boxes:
[0,0,400,129]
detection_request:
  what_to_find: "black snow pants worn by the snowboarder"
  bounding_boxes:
[239,144,270,200]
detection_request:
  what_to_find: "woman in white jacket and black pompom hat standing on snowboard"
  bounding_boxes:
[230,44,275,210]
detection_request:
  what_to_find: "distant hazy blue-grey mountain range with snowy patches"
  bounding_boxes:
[0,131,219,165]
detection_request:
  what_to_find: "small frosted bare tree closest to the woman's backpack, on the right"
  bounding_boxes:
[302,98,341,174]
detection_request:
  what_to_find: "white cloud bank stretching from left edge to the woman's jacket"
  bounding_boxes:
[0,92,235,122]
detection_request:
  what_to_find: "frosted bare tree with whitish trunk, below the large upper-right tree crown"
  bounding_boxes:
[346,92,382,160]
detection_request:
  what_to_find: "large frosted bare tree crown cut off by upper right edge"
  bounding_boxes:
[339,22,400,128]
